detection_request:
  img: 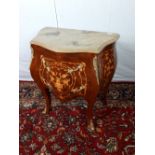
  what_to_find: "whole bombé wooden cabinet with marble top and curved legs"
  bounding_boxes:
[30,28,119,130]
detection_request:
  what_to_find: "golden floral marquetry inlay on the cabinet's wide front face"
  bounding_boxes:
[39,56,87,100]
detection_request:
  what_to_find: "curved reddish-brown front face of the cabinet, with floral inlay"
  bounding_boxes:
[30,45,99,101]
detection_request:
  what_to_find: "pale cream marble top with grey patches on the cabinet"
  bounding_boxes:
[31,27,119,53]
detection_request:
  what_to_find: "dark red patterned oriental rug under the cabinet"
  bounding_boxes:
[19,81,135,155]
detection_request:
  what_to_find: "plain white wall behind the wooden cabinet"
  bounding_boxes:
[19,0,135,81]
